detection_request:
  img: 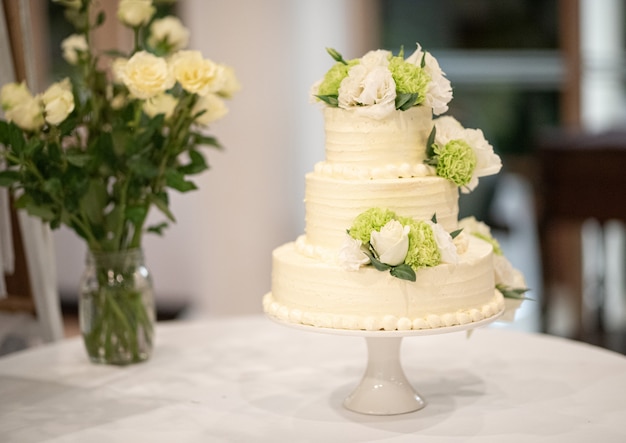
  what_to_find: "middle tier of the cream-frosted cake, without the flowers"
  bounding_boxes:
[304,172,459,249]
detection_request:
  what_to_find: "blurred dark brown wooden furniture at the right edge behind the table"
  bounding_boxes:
[537,131,626,339]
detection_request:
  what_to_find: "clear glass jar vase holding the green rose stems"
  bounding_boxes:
[79,249,156,365]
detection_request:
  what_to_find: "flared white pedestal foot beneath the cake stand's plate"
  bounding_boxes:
[343,337,426,415]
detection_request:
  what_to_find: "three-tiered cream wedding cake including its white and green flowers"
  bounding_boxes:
[263,45,524,330]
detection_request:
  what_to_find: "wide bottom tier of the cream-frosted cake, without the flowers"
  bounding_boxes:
[263,239,504,331]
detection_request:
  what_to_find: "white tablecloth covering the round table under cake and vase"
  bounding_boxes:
[0,317,626,443]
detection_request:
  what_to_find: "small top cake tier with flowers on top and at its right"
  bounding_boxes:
[312,44,502,193]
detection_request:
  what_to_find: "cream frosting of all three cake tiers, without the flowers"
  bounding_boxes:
[263,107,504,331]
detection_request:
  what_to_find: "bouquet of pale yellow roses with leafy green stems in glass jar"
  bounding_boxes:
[0,0,240,360]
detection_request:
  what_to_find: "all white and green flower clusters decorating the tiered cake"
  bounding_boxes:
[311,44,528,311]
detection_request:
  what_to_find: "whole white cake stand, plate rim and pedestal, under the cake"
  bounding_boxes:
[268,311,503,415]
